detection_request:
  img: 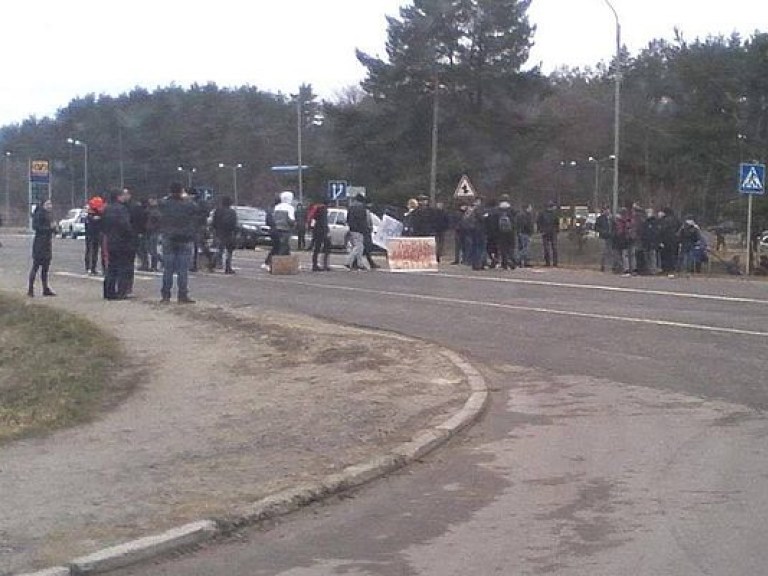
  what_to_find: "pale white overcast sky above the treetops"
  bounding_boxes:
[0,0,766,125]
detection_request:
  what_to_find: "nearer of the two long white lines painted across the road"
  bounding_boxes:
[263,276,768,338]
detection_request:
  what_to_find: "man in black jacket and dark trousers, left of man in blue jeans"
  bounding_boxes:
[102,189,136,300]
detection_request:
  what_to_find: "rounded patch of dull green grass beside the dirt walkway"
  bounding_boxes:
[0,293,125,443]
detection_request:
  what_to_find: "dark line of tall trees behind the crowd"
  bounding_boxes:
[0,0,768,227]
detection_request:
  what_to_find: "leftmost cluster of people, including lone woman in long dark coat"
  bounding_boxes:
[27,183,243,303]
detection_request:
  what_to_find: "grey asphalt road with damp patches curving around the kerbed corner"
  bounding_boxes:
[0,238,768,576]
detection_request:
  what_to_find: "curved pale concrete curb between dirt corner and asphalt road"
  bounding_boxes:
[18,350,490,576]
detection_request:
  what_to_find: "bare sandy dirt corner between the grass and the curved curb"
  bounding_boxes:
[0,280,468,574]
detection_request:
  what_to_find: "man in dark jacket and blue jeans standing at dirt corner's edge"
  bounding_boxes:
[160,182,198,304]
